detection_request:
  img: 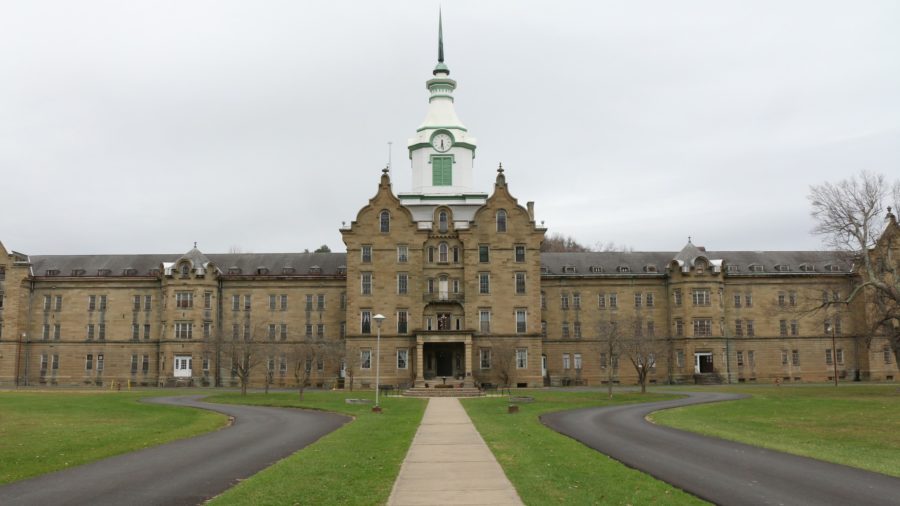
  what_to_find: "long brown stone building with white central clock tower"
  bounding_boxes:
[0,25,898,387]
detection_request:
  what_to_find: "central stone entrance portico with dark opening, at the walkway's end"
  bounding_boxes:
[416,331,475,388]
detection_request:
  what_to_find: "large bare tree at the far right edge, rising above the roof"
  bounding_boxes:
[808,171,900,361]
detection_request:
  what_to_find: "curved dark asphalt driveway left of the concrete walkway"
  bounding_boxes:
[0,396,350,505]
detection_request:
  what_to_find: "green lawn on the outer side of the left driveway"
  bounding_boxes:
[0,391,228,484]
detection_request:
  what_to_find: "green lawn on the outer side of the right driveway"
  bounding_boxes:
[651,385,900,477]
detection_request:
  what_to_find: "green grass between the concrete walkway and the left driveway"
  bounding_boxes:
[206,391,426,505]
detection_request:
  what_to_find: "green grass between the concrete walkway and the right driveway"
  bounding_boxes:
[463,391,705,505]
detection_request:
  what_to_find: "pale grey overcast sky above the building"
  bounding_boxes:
[0,0,900,254]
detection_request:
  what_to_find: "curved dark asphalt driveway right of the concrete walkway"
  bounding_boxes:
[541,392,900,506]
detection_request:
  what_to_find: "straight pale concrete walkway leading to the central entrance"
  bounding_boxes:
[388,397,522,506]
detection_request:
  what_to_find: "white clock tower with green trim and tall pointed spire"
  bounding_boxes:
[400,11,480,201]
